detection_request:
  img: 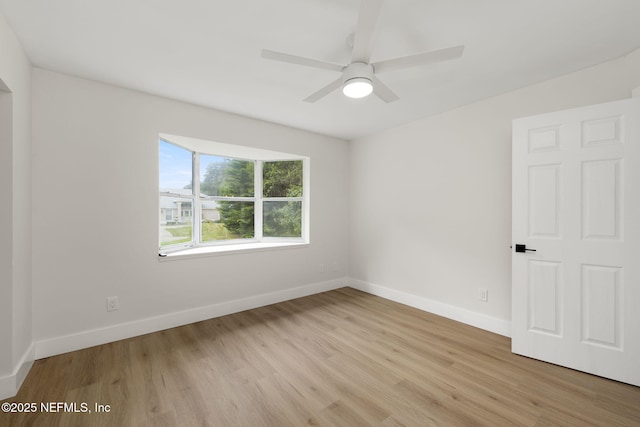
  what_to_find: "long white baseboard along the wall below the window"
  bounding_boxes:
[35,278,347,359]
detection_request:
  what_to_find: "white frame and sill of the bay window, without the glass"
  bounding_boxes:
[157,134,310,259]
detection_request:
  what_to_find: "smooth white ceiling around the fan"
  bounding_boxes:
[0,0,640,139]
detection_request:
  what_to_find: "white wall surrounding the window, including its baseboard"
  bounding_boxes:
[33,68,348,357]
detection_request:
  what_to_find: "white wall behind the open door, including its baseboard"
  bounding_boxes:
[350,47,640,334]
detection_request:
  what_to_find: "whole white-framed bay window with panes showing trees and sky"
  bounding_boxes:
[159,135,308,253]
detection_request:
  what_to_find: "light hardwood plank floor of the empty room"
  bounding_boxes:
[0,288,640,427]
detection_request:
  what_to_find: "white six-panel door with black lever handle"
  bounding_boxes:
[512,98,640,386]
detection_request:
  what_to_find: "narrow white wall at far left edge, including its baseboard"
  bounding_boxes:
[0,15,33,398]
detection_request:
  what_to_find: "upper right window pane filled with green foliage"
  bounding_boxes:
[262,160,302,198]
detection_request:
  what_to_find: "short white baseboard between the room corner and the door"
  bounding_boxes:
[348,278,511,337]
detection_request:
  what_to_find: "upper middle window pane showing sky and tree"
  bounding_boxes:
[200,154,254,197]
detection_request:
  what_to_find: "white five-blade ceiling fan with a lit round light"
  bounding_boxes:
[262,0,464,103]
